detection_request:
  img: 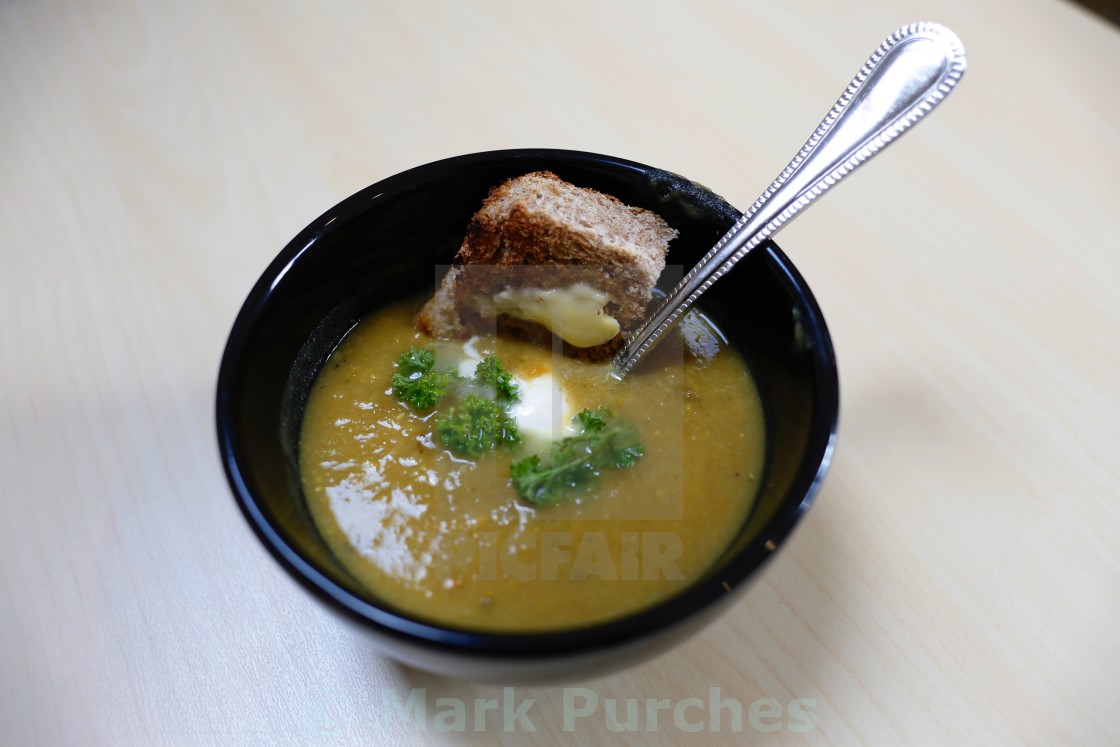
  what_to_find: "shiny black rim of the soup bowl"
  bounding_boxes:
[215,148,839,659]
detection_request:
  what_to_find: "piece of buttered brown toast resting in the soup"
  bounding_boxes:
[417,171,678,361]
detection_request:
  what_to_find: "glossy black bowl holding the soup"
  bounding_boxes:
[217,149,839,682]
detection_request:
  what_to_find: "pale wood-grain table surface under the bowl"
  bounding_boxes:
[0,0,1120,745]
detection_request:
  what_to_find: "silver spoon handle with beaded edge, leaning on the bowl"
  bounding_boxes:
[612,24,965,379]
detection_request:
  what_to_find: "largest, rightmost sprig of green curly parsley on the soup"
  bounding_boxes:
[510,408,645,506]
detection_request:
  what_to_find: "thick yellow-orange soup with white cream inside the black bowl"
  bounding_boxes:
[299,302,765,633]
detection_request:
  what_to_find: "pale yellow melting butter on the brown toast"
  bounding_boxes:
[494,282,620,347]
